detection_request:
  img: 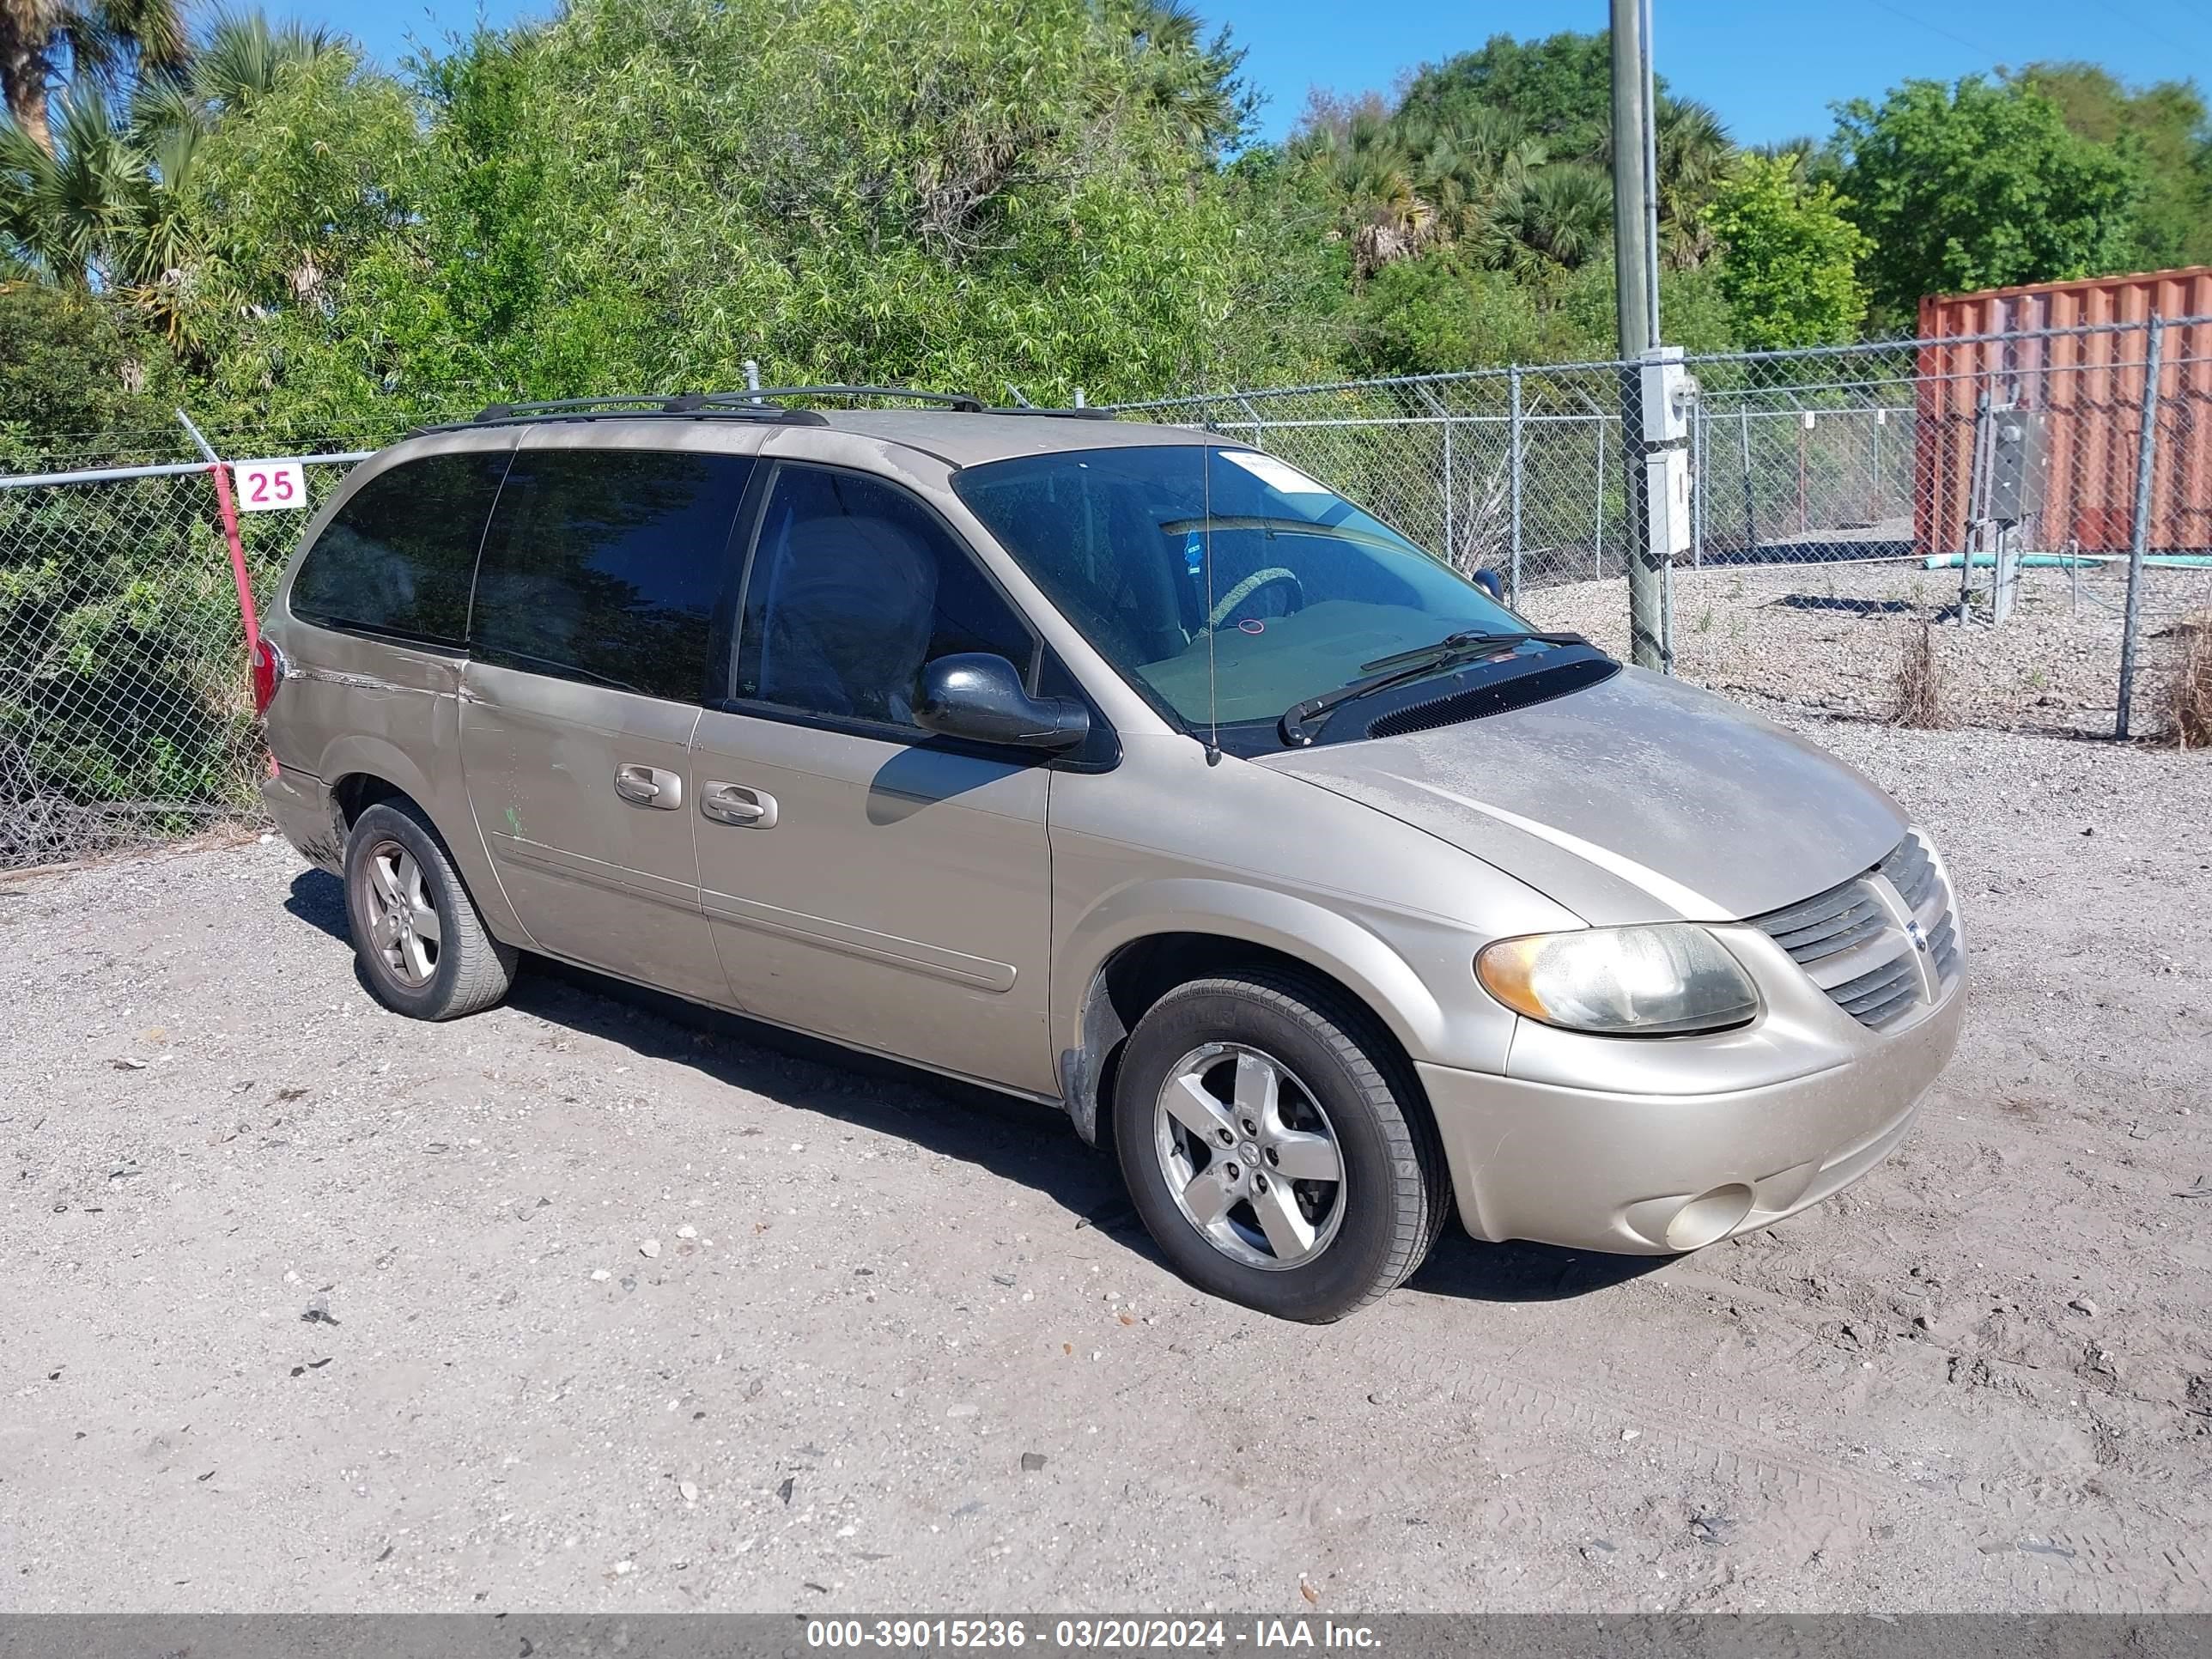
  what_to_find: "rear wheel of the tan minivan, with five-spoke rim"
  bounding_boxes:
[345,799,518,1020]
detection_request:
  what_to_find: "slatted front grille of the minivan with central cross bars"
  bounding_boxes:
[1752,834,1960,1030]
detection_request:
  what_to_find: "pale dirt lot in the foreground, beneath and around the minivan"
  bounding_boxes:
[0,726,2212,1613]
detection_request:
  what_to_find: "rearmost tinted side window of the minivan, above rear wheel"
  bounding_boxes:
[292,449,507,646]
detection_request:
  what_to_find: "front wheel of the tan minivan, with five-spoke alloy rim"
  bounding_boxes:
[1113,969,1451,1325]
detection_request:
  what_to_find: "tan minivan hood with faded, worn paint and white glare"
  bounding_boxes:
[1259,668,1905,927]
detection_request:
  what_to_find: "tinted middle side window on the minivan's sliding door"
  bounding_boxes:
[469,449,752,702]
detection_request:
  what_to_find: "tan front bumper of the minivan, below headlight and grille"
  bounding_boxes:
[1416,984,1966,1256]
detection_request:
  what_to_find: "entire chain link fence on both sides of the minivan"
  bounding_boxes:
[0,319,2212,869]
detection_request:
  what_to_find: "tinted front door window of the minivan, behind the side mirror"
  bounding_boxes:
[737,467,1033,726]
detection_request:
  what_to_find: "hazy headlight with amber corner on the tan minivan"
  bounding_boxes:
[1475,922,1759,1037]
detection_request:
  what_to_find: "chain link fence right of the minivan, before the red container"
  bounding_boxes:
[1121,319,2212,737]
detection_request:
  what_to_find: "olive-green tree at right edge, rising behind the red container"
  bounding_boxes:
[2020,64,2212,270]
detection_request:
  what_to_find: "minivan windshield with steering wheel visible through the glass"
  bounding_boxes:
[953,445,1528,726]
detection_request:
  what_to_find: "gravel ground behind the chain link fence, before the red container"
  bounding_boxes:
[1528,562,2212,737]
